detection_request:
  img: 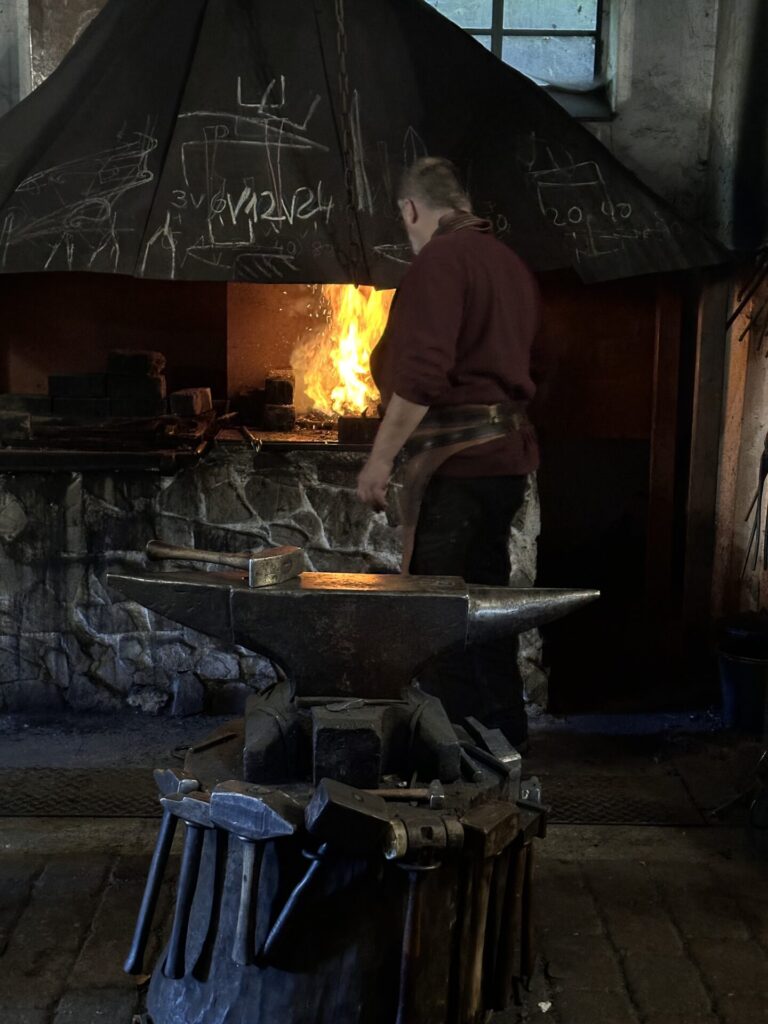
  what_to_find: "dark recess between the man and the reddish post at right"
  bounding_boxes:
[534,274,675,712]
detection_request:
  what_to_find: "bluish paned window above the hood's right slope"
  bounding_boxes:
[427,0,603,87]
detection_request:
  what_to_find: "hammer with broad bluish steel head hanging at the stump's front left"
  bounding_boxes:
[211,781,304,967]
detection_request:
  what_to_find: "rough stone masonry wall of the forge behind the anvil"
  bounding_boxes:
[0,444,546,715]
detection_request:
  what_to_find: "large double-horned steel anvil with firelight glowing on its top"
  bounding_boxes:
[108,571,599,699]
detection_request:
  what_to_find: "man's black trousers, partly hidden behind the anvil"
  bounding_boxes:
[411,476,527,743]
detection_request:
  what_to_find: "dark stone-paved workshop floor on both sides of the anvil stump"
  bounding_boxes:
[0,717,768,1024]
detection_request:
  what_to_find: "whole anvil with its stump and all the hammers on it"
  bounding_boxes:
[108,543,598,1024]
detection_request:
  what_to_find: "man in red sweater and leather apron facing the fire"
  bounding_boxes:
[357,158,539,744]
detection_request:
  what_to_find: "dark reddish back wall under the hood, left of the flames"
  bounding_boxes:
[0,273,226,397]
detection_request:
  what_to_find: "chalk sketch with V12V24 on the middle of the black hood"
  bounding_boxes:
[141,76,339,280]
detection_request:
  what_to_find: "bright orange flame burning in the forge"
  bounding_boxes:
[291,285,394,416]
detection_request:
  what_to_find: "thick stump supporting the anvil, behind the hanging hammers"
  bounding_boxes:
[140,698,544,1024]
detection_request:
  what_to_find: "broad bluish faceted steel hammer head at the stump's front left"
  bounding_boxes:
[211,781,304,842]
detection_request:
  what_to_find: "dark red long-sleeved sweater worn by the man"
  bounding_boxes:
[371,217,539,476]
